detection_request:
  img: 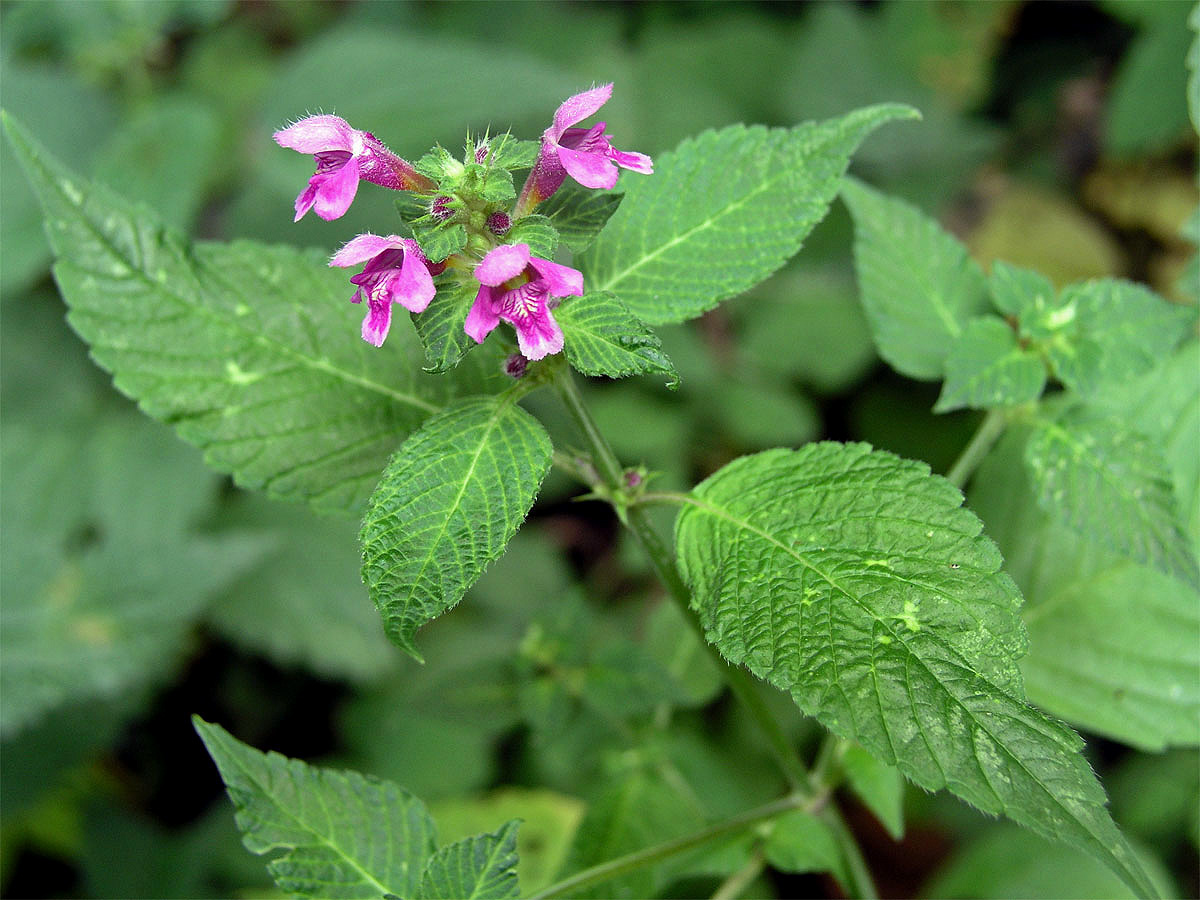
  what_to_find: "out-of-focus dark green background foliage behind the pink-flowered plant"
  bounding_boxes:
[0,0,1200,898]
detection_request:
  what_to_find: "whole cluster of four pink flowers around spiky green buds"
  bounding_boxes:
[275,84,654,360]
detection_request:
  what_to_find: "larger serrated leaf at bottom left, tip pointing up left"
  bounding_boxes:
[192,716,434,899]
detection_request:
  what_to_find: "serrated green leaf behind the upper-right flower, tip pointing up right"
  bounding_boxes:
[580,104,917,325]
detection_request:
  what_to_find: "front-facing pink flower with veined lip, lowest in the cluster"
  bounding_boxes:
[463,244,583,359]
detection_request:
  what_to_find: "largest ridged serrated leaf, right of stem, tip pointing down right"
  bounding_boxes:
[676,443,1153,895]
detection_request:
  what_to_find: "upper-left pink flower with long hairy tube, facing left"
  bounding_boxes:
[274,115,432,222]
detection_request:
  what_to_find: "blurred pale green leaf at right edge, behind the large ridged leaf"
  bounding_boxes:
[971,408,1200,750]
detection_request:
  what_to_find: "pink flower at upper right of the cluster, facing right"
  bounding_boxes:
[517,84,654,212]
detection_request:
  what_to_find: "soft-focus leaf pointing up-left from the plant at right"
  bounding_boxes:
[841,179,988,380]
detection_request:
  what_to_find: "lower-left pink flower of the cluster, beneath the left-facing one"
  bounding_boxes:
[329,234,445,347]
